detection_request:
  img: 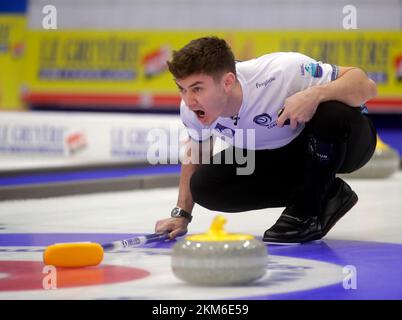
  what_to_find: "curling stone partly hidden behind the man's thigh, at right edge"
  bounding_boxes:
[339,135,400,179]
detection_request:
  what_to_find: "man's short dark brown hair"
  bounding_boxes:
[167,37,236,79]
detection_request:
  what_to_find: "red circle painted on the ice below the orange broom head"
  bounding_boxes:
[0,261,150,291]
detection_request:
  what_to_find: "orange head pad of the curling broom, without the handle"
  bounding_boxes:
[43,242,103,267]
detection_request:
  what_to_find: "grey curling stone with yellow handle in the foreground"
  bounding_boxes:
[172,216,267,286]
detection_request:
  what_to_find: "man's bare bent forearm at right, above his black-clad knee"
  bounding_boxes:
[310,68,377,106]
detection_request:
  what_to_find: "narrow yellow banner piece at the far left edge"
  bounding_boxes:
[0,15,26,109]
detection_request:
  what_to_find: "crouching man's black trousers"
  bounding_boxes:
[190,101,377,212]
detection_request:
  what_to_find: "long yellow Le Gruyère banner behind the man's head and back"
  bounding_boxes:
[26,31,402,97]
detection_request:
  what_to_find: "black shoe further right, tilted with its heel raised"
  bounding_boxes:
[319,178,358,237]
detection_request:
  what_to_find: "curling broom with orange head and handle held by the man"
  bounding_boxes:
[43,233,169,267]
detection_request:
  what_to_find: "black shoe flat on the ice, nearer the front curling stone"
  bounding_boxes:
[262,205,322,244]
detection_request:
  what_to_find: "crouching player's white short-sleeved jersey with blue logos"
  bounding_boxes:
[180,52,338,150]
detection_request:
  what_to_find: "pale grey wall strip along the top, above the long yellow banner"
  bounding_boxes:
[28,0,402,31]
